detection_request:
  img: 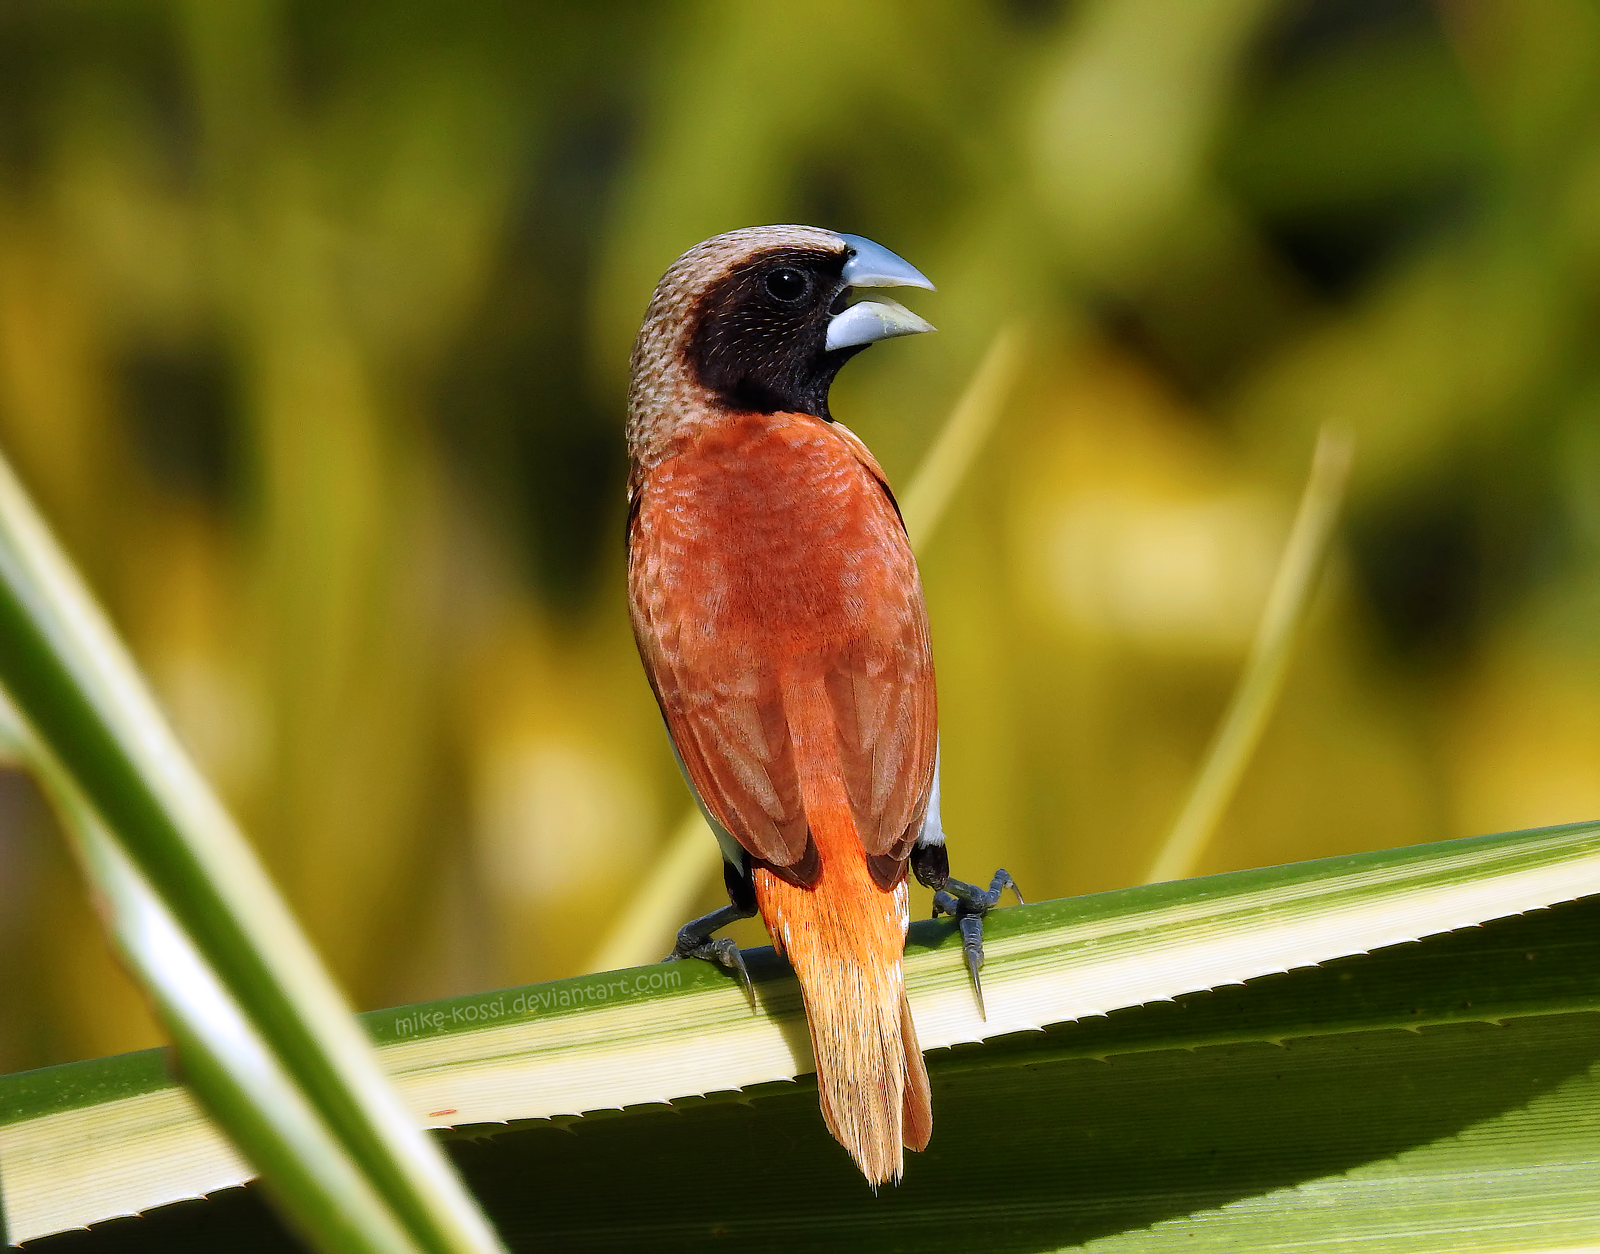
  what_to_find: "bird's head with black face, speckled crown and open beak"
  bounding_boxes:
[629,226,933,457]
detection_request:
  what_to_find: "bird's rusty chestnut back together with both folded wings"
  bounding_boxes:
[629,414,938,867]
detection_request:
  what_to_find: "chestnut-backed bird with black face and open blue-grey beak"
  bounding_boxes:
[627,226,1021,1190]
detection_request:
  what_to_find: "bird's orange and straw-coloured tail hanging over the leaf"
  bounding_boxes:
[755,716,933,1188]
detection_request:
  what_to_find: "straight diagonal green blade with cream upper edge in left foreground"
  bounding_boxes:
[0,462,499,1251]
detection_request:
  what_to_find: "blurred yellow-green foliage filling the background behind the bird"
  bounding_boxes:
[0,0,1600,1070]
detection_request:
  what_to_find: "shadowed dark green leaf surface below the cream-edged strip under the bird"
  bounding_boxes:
[458,902,1600,1254]
